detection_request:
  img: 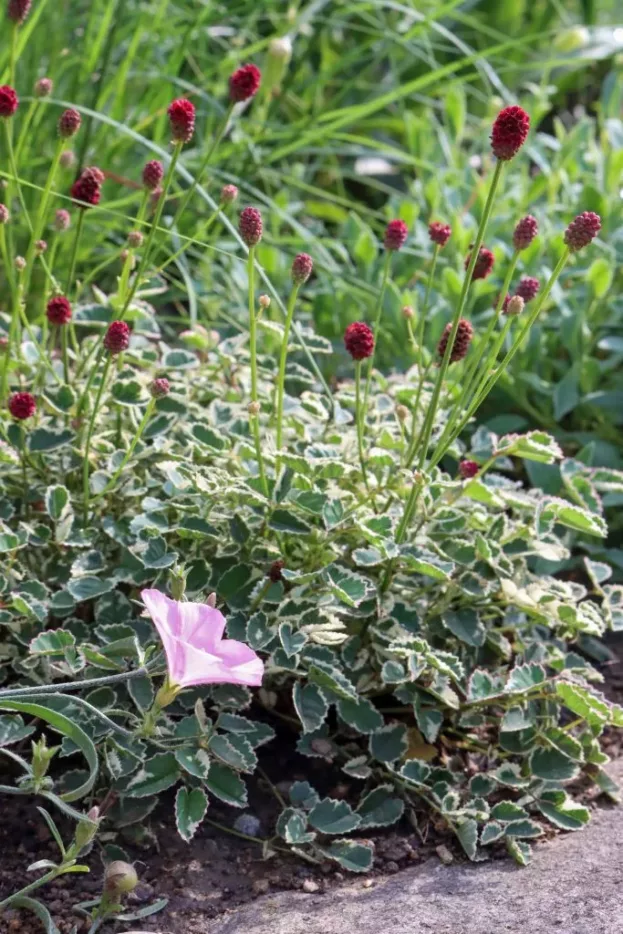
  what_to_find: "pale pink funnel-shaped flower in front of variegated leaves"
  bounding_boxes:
[141,590,264,688]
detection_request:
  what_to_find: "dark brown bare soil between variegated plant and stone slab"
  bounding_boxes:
[0,642,623,934]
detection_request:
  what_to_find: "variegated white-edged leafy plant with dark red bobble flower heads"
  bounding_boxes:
[0,3,623,930]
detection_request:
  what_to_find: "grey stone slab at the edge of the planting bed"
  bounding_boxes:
[211,760,623,934]
